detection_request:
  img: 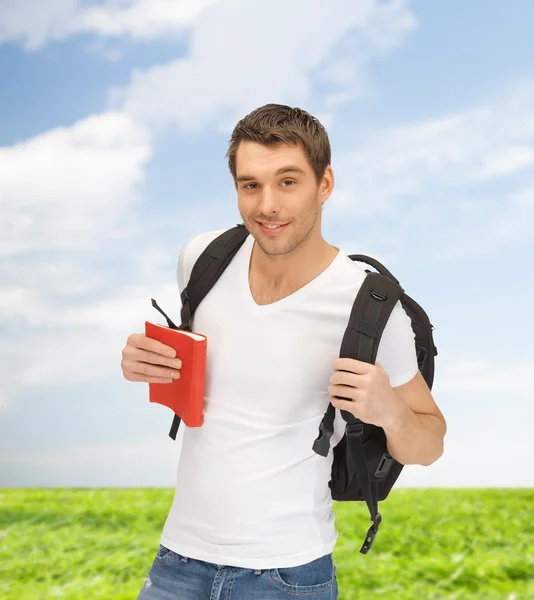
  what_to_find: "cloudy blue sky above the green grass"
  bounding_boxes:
[0,0,534,487]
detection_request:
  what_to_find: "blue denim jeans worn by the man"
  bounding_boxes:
[137,544,338,600]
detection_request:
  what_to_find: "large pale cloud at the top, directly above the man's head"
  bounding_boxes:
[111,0,415,132]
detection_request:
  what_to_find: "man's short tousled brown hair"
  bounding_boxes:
[226,104,331,184]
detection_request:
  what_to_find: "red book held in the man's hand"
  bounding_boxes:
[145,321,208,427]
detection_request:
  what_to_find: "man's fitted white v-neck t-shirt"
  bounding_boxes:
[161,230,418,569]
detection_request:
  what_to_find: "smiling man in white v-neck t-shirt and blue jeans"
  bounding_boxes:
[122,104,446,600]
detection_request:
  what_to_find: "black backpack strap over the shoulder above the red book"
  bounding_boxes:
[169,223,249,440]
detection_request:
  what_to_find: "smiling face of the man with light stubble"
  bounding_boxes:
[236,141,333,255]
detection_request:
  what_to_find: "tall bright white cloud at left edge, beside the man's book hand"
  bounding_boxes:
[0,112,157,407]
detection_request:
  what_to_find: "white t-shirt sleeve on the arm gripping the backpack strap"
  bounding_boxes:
[376,300,419,387]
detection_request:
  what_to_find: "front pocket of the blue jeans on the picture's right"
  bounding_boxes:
[271,554,334,596]
